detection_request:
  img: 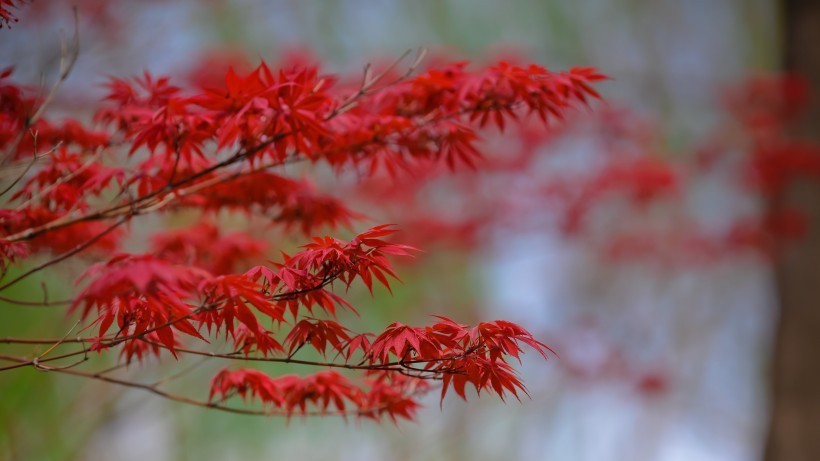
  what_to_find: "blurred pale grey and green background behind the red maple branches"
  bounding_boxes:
[0,0,808,461]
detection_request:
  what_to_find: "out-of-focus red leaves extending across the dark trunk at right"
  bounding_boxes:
[524,75,820,265]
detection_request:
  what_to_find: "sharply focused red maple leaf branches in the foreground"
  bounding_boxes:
[0,9,604,421]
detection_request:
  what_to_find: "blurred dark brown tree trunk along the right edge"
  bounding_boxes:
[766,0,820,461]
